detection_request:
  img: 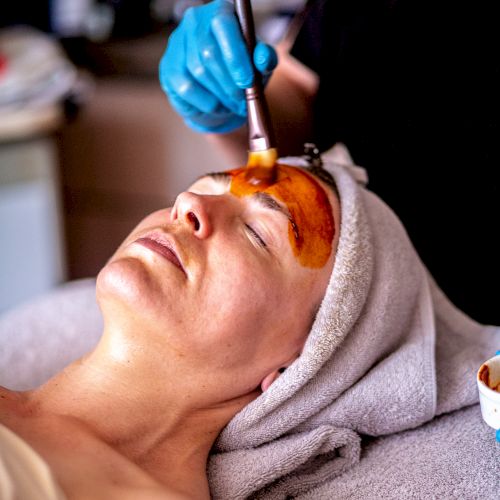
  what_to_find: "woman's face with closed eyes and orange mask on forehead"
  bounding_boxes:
[97,166,340,396]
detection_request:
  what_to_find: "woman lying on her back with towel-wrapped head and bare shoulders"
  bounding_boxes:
[0,146,499,500]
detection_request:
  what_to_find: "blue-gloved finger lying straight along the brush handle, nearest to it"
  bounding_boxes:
[210,1,253,89]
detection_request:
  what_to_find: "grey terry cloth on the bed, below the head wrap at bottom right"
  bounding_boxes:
[299,405,500,500]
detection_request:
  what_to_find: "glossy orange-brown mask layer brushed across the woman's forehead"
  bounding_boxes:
[229,164,335,268]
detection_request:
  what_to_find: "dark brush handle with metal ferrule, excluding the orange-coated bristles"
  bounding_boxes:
[234,0,275,152]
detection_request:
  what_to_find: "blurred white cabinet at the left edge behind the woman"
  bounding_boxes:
[0,137,65,313]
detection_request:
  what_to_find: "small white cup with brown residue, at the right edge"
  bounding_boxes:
[477,355,500,429]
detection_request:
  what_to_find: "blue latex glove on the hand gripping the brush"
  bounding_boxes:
[160,0,278,133]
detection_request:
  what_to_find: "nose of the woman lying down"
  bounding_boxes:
[171,191,213,239]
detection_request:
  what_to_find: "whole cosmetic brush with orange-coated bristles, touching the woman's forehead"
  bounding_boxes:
[234,0,278,184]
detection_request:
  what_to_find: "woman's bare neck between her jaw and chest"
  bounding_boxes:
[23,330,255,498]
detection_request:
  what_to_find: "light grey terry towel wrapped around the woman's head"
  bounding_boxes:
[208,145,500,499]
